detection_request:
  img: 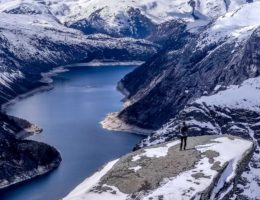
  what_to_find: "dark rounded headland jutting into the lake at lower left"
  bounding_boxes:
[0,114,61,189]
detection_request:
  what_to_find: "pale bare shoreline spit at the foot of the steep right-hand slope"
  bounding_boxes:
[100,112,154,136]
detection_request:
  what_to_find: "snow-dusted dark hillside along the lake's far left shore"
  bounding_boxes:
[0,9,159,103]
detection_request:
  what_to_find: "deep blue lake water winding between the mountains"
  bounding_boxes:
[0,66,143,200]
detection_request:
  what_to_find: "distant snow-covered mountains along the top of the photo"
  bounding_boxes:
[0,0,252,38]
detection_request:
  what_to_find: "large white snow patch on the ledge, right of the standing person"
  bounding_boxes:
[144,137,252,200]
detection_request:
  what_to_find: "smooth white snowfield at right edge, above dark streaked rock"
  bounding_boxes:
[196,77,260,112]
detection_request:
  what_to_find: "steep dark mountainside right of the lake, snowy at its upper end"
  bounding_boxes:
[114,2,260,129]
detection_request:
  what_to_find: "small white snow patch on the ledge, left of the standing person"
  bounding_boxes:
[132,140,180,162]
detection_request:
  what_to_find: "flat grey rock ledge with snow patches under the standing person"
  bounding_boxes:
[63,135,254,200]
